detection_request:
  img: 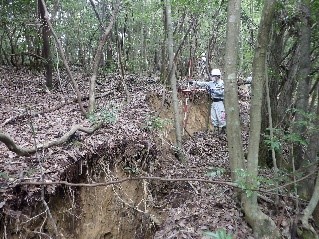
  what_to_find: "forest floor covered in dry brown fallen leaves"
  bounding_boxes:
[0,67,294,239]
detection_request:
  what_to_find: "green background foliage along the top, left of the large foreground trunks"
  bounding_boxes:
[0,0,250,73]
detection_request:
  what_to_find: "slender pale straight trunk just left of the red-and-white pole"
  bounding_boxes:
[165,0,184,160]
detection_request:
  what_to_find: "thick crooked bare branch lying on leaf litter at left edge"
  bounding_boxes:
[0,123,102,156]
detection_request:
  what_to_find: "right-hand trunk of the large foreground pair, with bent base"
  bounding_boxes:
[243,0,280,239]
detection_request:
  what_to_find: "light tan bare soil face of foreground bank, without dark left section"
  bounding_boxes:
[50,166,158,239]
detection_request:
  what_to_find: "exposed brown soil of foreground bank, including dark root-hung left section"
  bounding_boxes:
[0,144,162,239]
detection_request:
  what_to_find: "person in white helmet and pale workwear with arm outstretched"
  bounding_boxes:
[190,69,226,134]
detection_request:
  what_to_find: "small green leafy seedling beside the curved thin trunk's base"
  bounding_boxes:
[88,106,118,124]
